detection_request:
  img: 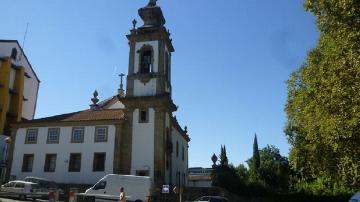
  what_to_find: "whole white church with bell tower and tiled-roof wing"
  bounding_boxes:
[8,0,190,191]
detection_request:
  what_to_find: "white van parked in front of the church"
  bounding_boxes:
[85,174,152,202]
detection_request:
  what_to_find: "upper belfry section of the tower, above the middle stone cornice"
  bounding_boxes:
[126,0,174,96]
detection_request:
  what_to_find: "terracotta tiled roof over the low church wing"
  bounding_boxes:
[21,109,125,123]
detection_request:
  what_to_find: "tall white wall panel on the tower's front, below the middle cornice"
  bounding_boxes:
[131,108,155,179]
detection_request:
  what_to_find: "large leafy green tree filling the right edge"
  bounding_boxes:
[285,0,360,189]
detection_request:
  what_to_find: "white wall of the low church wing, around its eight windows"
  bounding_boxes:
[11,125,115,184]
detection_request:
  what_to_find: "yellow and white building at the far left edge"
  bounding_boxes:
[0,40,40,180]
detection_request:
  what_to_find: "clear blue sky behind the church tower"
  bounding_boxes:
[0,0,319,167]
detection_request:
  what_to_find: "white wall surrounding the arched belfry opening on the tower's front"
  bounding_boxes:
[134,41,159,73]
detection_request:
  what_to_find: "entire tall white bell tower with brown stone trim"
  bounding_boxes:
[119,0,177,191]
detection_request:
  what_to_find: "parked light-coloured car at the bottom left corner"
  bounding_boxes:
[1,180,48,200]
